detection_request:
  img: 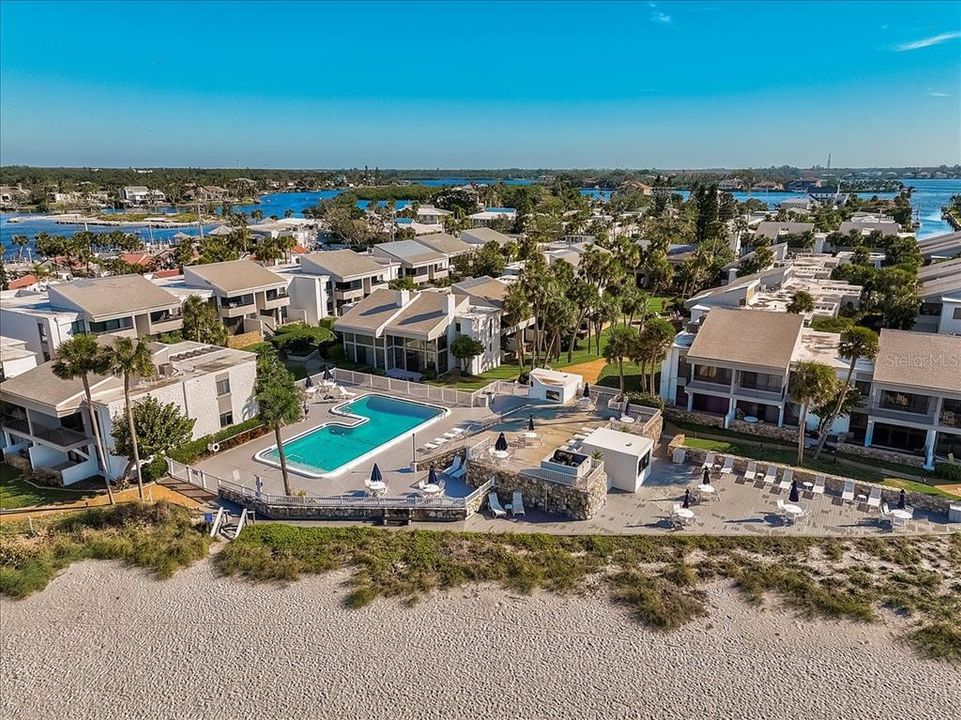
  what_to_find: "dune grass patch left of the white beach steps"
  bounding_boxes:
[0,502,210,598]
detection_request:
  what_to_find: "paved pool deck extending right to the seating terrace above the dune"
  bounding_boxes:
[191,396,961,537]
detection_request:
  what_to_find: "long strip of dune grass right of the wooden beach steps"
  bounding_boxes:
[215,524,961,659]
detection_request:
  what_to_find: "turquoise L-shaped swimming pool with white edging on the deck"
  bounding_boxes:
[254,393,450,478]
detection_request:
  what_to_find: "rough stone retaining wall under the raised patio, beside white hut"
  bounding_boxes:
[466,460,607,520]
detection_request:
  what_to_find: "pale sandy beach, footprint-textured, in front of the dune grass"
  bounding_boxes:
[0,561,961,720]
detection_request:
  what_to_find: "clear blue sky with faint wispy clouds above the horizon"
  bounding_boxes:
[0,0,961,168]
